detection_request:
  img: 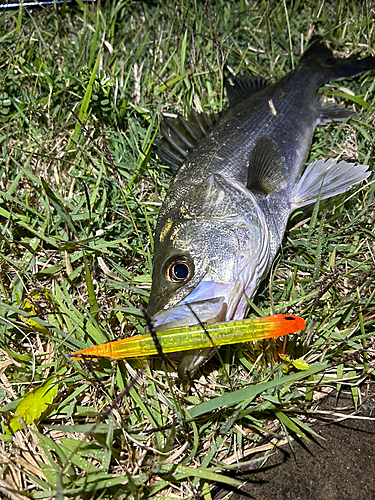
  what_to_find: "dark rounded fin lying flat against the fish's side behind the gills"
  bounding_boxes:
[247,136,287,195]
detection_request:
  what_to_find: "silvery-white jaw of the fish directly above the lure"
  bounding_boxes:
[152,281,244,332]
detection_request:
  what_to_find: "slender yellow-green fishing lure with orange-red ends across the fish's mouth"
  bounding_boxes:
[72,314,306,359]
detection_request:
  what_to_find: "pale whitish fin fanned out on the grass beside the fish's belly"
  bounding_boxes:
[292,159,371,208]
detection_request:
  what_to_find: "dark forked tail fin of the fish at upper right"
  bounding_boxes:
[299,36,375,85]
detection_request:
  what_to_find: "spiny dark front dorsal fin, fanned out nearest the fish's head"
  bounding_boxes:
[156,110,217,174]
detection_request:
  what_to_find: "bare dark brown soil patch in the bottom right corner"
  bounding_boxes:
[214,385,375,500]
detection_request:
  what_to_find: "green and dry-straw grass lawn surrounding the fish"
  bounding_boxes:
[0,0,375,500]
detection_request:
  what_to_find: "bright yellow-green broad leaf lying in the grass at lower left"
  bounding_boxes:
[8,376,58,433]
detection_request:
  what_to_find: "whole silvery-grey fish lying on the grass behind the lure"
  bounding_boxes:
[147,37,375,380]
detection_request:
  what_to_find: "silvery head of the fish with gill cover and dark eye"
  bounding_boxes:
[148,174,270,331]
